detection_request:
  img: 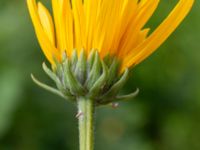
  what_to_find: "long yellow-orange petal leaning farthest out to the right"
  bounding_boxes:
[122,0,194,70]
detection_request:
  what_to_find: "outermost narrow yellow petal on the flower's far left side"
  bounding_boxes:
[27,0,60,64]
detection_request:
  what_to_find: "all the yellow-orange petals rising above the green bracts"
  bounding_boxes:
[27,0,194,72]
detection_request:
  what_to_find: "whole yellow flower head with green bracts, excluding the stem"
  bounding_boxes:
[27,0,194,149]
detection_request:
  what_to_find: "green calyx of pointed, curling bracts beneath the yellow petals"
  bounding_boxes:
[31,50,139,106]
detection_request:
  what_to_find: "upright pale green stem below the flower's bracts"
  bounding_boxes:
[78,97,95,150]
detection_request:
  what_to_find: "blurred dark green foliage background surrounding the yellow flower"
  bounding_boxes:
[0,0,200,150]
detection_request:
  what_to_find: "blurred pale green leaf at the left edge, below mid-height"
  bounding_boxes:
[0,70,22,138]
